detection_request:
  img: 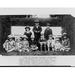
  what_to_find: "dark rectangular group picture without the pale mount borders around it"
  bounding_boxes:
[0,14,75,56]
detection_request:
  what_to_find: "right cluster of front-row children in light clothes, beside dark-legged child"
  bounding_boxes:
[47,35,70,51]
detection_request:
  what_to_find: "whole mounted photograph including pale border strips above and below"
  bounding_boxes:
[0,8,75,66]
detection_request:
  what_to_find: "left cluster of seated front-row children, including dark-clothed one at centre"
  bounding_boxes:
[3,37,38,52]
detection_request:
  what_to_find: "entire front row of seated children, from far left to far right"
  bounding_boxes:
[3,35,70,52]
